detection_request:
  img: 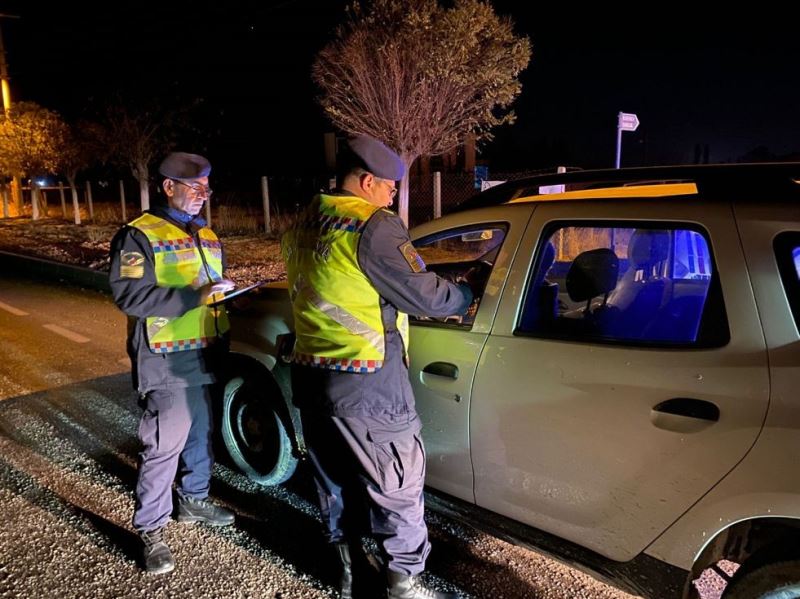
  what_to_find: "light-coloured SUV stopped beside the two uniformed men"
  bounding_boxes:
[222,164,800,598]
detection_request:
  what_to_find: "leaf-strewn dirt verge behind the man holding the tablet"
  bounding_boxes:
[0,218,286,285]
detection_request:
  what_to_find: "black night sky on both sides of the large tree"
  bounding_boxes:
[0,0,800,183]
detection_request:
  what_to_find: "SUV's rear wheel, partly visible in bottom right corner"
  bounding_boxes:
[723,559,800,599]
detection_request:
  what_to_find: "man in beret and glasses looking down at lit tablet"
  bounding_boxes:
[109,152,234,574]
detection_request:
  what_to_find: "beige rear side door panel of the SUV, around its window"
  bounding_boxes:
[471,199,768,560]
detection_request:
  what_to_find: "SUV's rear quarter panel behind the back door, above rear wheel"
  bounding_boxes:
[646,198,800,568]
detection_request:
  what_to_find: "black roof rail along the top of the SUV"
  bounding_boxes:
[452,162,800,212]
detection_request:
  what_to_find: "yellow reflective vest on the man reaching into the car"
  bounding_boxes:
[281,194,408,373]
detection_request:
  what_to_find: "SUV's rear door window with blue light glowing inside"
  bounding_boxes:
[515,223,729,347]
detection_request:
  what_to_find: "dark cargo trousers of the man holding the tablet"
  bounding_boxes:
[133,386,214,531]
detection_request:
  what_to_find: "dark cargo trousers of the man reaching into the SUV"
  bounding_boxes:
[302,411,430,575]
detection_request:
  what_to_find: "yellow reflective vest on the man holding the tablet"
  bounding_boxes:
[129,213,230,354]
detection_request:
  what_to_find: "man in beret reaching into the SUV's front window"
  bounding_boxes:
[282,135,472,599]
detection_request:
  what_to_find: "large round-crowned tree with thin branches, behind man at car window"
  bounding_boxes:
[312,0,531,222]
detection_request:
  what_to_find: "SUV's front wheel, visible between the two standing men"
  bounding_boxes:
[221,375,297,486]
